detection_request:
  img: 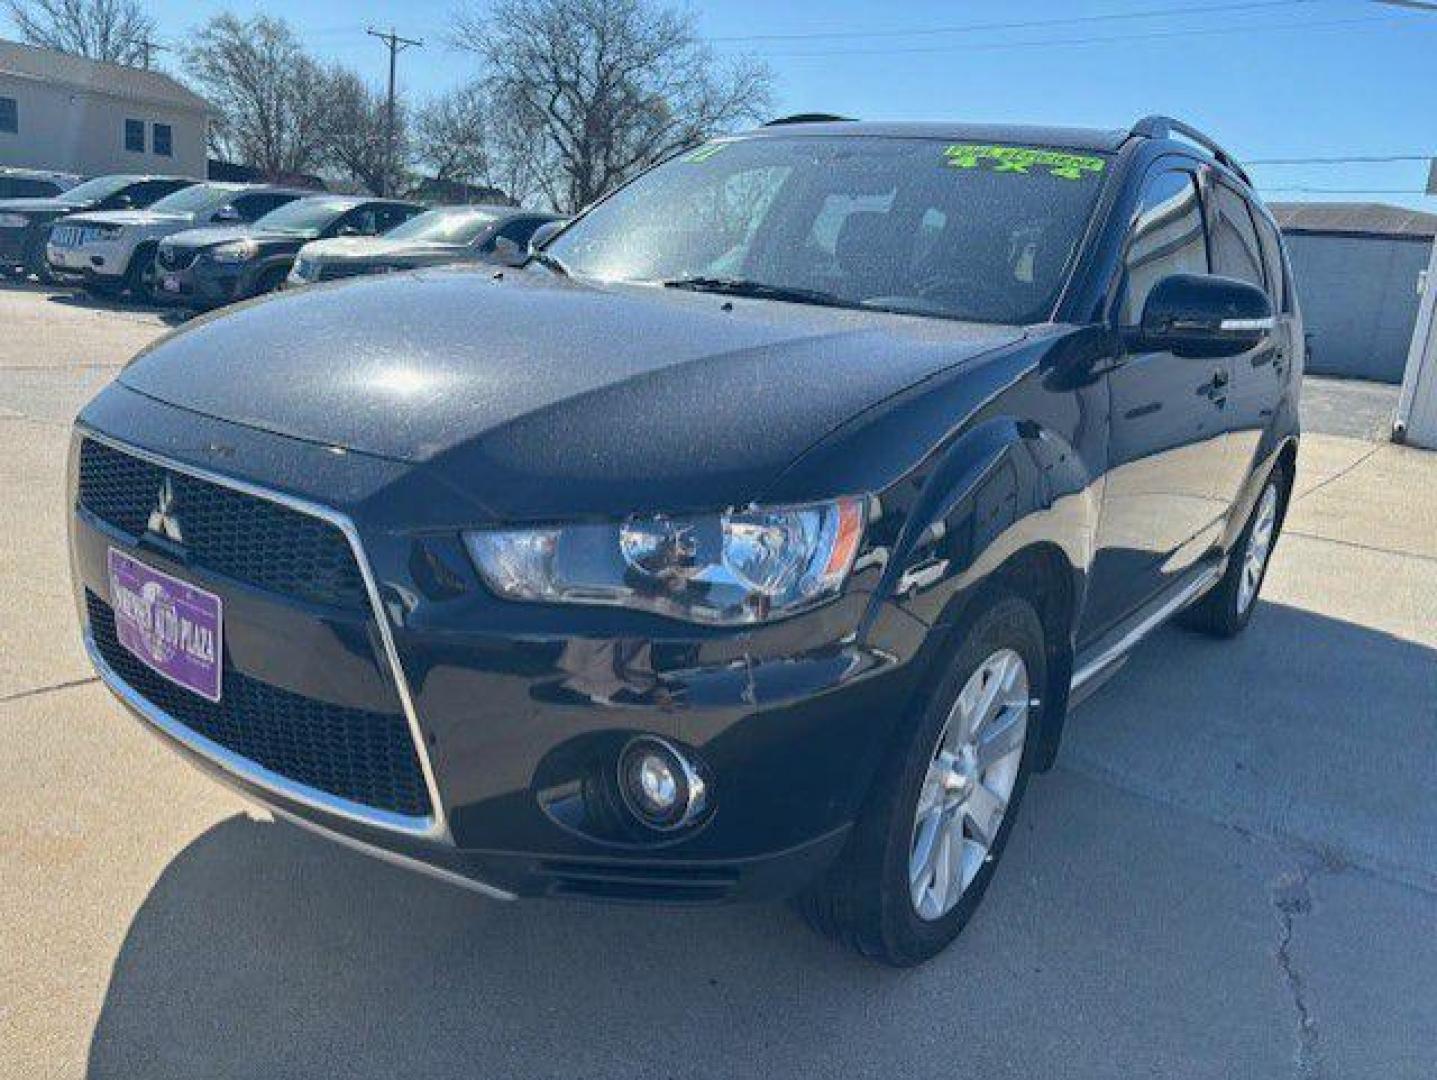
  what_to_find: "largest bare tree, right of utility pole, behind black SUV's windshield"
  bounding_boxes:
[454,0,772,210]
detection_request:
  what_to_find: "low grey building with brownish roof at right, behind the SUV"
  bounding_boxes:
[1267,203,1437,385]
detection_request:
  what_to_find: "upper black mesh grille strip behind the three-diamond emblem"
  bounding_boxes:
[79,439,366,610]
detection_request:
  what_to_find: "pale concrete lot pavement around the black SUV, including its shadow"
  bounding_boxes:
[0,280,1437,1080]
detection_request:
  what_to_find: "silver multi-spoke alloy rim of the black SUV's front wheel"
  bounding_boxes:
[908,649,1030,921]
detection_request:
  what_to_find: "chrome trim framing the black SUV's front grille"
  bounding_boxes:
[70,424,453,843]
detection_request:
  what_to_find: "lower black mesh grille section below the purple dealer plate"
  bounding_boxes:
[85,590,430,817]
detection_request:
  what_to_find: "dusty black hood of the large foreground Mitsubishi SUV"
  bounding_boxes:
[121,269,1023,518]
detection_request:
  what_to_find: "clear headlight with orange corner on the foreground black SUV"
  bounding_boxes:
[464,497,867,626]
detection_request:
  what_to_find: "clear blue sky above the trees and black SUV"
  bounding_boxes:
[5,0,1437,210]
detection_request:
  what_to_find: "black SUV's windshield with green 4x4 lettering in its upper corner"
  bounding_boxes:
[547,135,1106,323]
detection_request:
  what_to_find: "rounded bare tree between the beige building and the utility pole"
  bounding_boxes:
[184,14,329,177]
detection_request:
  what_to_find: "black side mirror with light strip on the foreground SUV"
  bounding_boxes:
[1135,274,1276,358]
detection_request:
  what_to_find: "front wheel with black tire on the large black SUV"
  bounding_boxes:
[795,592,1048,967]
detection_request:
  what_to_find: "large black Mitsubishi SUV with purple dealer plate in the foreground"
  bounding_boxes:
[70,118,1302,964]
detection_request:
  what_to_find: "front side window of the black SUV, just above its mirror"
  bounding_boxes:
[1121,169,1210,326]
